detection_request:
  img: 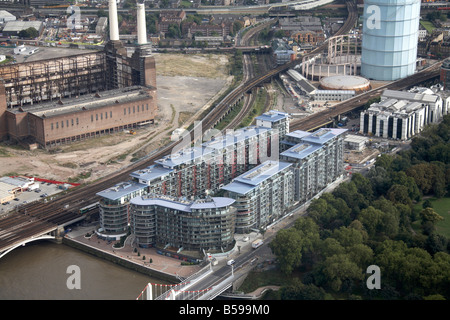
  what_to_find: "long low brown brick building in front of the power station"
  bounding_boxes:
[6,86,157,148]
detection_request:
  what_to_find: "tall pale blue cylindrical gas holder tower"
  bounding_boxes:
[361,0,420,81]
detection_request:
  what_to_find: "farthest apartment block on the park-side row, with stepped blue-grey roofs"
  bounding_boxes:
[280,128,347,203]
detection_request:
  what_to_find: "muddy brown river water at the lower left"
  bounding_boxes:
[0,241,166,300]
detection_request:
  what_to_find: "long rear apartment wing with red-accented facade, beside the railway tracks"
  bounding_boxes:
[131,111,289,198]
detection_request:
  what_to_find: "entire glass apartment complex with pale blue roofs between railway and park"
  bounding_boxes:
[94,111,347,253]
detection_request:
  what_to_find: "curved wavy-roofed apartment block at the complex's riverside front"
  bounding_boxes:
[130,195,236,253]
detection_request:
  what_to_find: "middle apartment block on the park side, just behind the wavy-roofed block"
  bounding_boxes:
[222,161,294,233]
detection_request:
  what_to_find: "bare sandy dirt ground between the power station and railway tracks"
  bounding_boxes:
[0,54,231,183]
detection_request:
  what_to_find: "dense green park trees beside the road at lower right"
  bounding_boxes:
[270,116,450,299]
